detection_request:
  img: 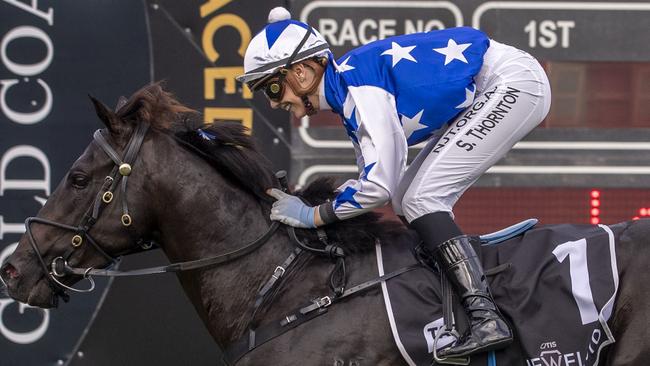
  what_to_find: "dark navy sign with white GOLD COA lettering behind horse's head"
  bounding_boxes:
[0,0,149,365]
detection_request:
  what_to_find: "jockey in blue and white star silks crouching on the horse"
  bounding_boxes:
[238,8,551,357]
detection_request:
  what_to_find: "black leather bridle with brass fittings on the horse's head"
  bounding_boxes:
[25,122,149,301]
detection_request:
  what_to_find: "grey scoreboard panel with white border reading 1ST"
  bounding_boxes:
[469,1,650,61]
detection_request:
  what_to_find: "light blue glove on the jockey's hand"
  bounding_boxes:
[268,188,316,228]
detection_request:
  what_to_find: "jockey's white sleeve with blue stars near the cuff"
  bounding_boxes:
[318,86,408,224]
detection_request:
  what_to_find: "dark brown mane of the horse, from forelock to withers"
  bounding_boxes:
[111,83,406,253]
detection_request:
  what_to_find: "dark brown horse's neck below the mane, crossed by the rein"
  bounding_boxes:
[147,134,287,345]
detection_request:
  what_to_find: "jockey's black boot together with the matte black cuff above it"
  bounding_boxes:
[410,212,512,358]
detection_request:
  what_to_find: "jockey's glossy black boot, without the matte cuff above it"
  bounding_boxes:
[433,235,512,358]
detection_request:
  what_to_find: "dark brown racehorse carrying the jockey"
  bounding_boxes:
[0,84,650,366]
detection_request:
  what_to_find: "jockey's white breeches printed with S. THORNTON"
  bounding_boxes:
[392,41,551,222]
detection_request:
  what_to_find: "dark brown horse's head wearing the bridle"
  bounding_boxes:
[0,84,210,308]
